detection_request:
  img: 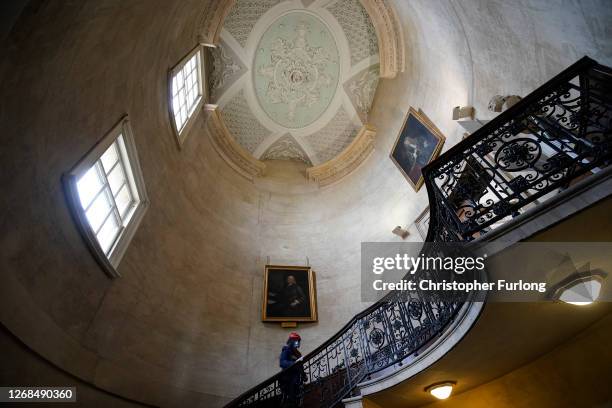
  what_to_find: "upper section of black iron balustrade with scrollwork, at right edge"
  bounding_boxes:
[423,57,612,242]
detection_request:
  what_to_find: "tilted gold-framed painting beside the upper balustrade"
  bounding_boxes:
[389,107,445,191]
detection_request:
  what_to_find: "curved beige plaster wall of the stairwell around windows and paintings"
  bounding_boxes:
[0,0,612,407]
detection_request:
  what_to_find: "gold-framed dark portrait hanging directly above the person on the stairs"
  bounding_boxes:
[262,265,317,322]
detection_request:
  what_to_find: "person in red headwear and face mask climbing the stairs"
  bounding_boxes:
[279,332,306,407]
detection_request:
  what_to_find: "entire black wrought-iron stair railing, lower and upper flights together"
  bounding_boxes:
[227,57,612,407]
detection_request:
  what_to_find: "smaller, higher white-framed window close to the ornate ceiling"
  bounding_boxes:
[170,45,204,145]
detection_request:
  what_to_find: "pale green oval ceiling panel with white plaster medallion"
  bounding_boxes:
[253,11,340,129]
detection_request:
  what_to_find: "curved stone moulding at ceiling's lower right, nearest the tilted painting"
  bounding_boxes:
[306,124,376,187]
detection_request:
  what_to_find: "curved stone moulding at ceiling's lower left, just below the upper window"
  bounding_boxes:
[206,107,266,181]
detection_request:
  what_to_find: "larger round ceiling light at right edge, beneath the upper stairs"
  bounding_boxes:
[551,270,607,306]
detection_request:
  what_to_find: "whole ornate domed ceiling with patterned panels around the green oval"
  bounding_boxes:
[210,0,379,166]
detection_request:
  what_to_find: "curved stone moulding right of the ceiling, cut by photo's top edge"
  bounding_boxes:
[360,0,406,78]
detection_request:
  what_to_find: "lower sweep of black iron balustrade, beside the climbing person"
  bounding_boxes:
[227,262,466,407]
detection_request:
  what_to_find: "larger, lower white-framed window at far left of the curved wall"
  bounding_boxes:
[64,118,148,276]
